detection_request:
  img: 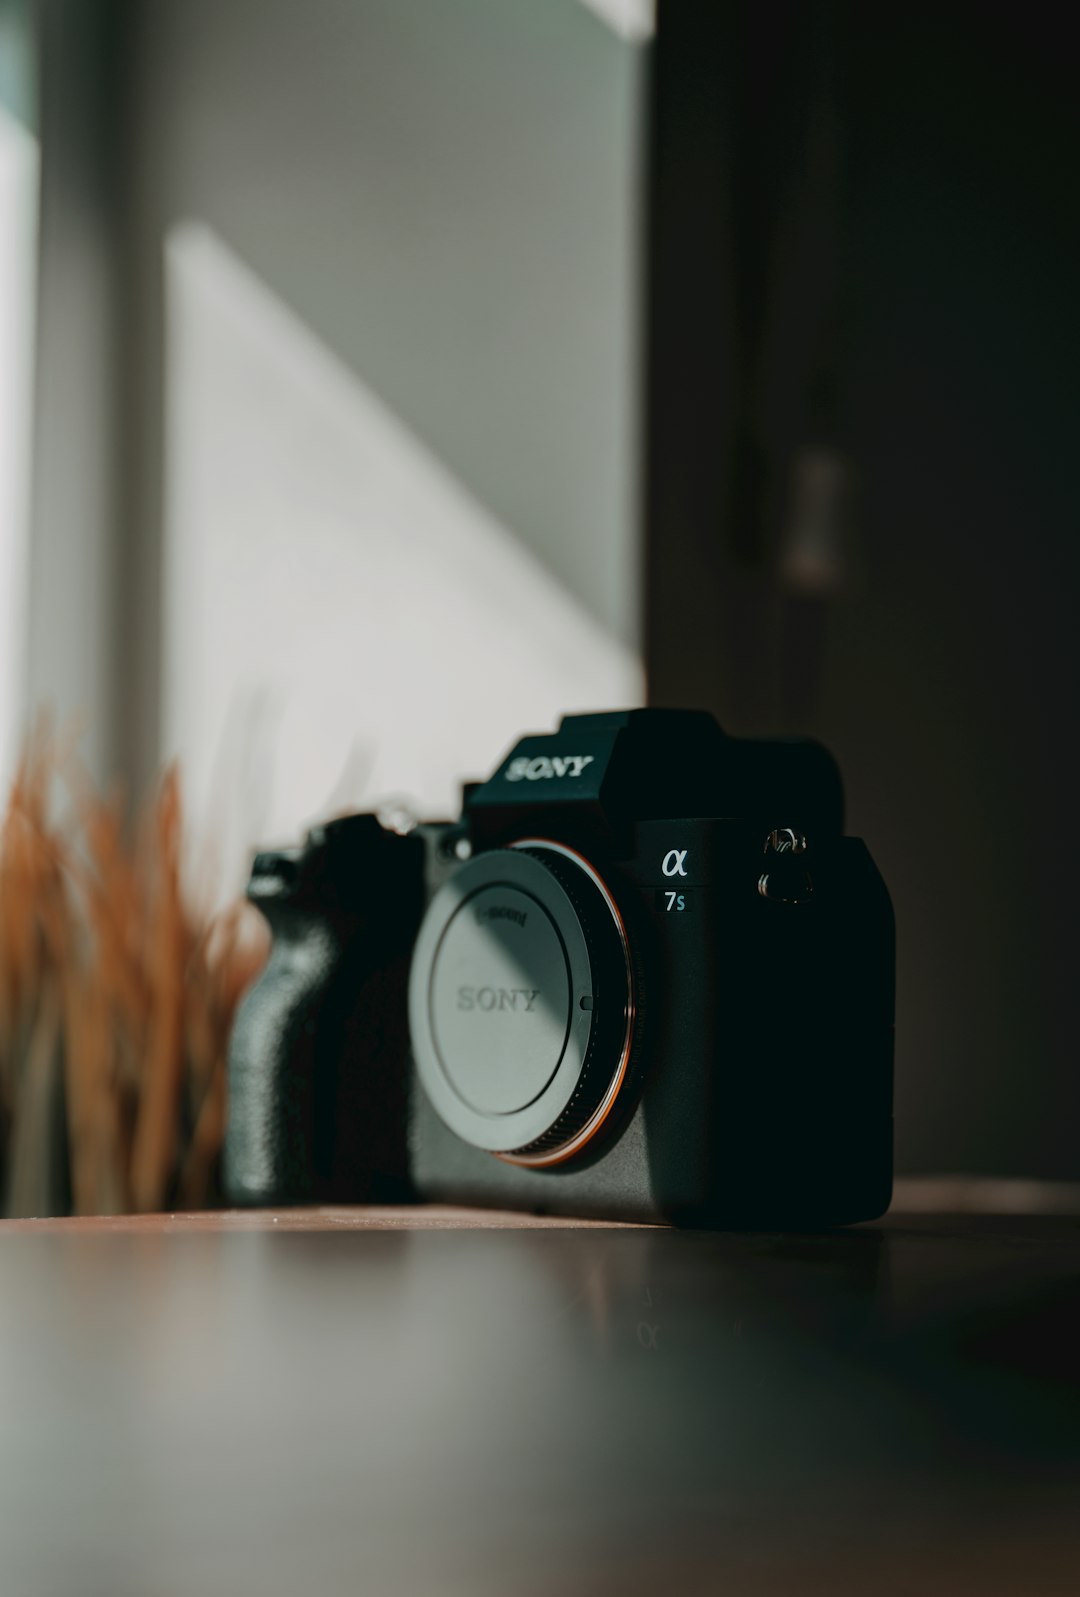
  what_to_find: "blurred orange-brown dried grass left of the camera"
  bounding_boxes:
[0,727,267,1214]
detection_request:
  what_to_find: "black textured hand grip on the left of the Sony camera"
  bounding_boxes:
[224,814,425,1204]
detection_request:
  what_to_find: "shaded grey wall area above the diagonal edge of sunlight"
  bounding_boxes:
[128,0,647,647]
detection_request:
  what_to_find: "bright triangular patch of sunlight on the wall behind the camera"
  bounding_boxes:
[163,222,644,885]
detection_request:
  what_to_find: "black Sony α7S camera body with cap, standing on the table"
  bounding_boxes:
[225,709,895,1228]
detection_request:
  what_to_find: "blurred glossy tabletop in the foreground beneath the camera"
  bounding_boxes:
[0,1209,1080,1597]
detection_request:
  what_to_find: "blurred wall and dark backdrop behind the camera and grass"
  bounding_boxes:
[0,0,1080,1200]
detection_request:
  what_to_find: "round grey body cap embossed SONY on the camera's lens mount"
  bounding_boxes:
[409,838,634,1167]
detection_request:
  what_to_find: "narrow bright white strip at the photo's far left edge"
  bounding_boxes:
[0,105,38,791]
